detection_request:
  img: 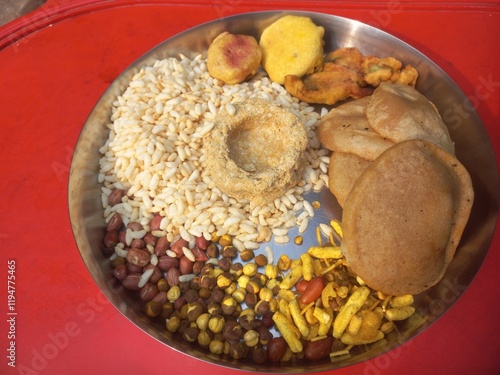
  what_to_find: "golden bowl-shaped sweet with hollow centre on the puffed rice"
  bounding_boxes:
[203,99,308,206]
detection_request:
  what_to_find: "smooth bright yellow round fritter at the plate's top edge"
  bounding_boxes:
[259,15,325,84]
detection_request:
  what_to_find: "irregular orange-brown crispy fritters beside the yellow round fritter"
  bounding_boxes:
[284,47,418,105]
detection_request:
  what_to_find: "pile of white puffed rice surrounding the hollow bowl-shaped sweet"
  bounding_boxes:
[98,55,329,245]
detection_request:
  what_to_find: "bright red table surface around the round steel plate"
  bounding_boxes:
[0,0,500,375]
